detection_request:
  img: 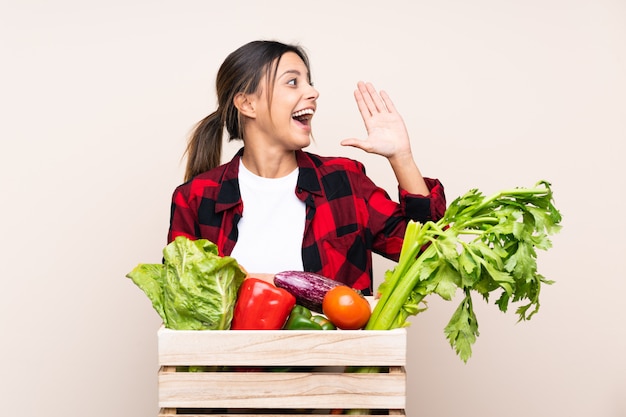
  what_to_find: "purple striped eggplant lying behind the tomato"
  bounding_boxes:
[274,271,345,314]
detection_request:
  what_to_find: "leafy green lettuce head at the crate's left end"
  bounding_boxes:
[126,236,245,330]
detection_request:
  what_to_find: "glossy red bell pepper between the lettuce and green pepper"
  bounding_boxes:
[231,277,296,330]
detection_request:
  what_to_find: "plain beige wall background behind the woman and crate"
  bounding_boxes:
[0,0,626,417]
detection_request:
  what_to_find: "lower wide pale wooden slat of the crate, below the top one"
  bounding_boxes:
[159,372,406,409]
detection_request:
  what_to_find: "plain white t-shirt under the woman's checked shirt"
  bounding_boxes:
[231,161,306,274]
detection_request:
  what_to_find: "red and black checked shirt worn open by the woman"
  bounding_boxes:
[168,149,446,294]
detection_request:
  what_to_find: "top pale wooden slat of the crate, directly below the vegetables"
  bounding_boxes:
[158,327,406,366]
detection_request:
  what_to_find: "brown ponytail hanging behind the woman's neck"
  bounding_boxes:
[185,110,224,181]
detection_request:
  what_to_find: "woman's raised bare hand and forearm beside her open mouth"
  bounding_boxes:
[341,82,430,196]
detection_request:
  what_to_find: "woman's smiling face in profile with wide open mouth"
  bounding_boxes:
[249,52,319,150]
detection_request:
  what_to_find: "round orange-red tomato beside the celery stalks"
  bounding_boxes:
[322,285,372,330]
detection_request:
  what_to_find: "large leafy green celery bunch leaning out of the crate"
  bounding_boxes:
[365,181,561,362]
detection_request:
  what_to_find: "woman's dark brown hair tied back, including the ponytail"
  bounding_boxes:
[185,41,310,181]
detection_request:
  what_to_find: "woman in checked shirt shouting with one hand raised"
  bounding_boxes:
[168,41,446,295]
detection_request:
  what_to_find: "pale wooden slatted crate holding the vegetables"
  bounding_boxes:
[158,328,407,417]
